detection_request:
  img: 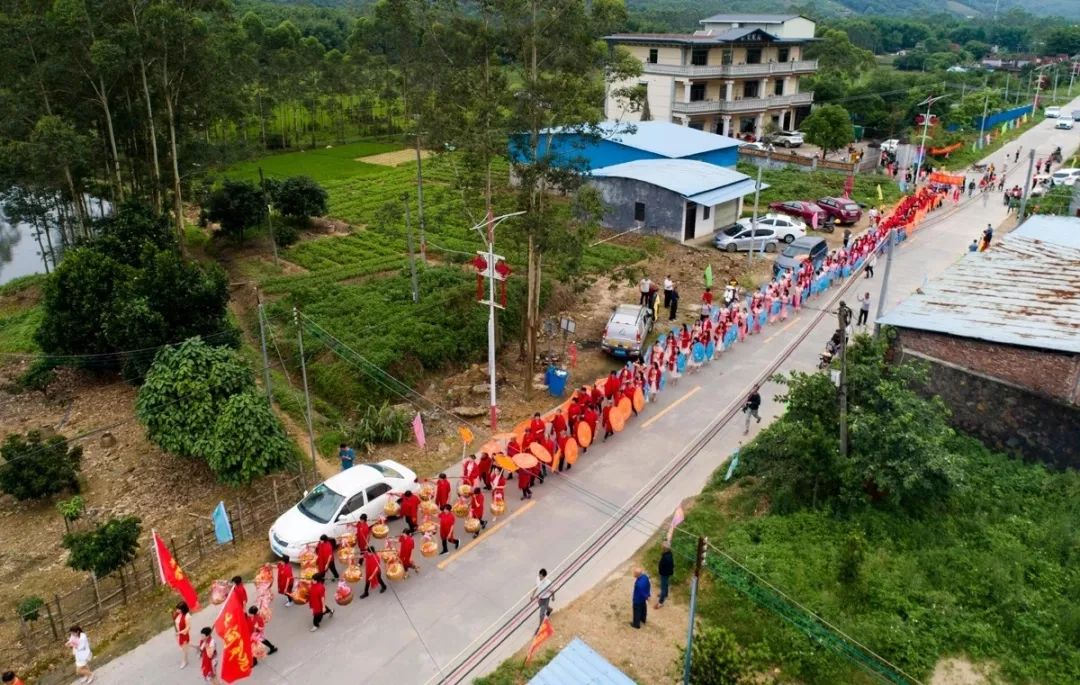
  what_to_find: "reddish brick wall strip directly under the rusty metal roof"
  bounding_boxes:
[899,328,1080,404]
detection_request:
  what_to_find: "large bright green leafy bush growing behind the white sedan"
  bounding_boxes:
[135,338,295,485]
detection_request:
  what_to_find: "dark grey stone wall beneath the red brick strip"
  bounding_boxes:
[902,348,1080,469]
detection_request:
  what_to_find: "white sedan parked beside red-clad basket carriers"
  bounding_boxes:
[269,459,420,559]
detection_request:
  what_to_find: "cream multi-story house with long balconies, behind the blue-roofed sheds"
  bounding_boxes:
[605,14,818,138]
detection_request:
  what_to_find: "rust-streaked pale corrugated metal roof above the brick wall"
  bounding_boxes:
[880,233,1080,353]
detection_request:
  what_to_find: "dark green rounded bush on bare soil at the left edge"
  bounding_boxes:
[0,431,82,500]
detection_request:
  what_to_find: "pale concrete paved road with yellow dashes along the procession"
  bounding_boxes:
[84,98,1080,685]
